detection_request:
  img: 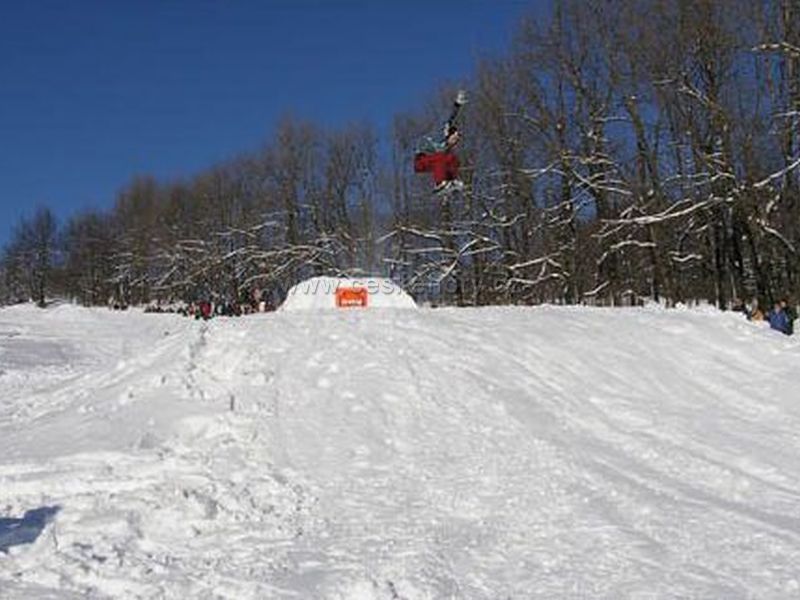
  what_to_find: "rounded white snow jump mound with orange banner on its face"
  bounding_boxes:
[281,277,417,311]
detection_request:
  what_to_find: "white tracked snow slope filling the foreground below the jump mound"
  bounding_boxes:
[0,306,800,600]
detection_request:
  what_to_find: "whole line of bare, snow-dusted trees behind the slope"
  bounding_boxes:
[0,0,800,306]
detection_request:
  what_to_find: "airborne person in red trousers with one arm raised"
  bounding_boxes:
[414,90,467,192]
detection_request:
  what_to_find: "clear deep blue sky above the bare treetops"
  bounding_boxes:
[0,0,550,245]
